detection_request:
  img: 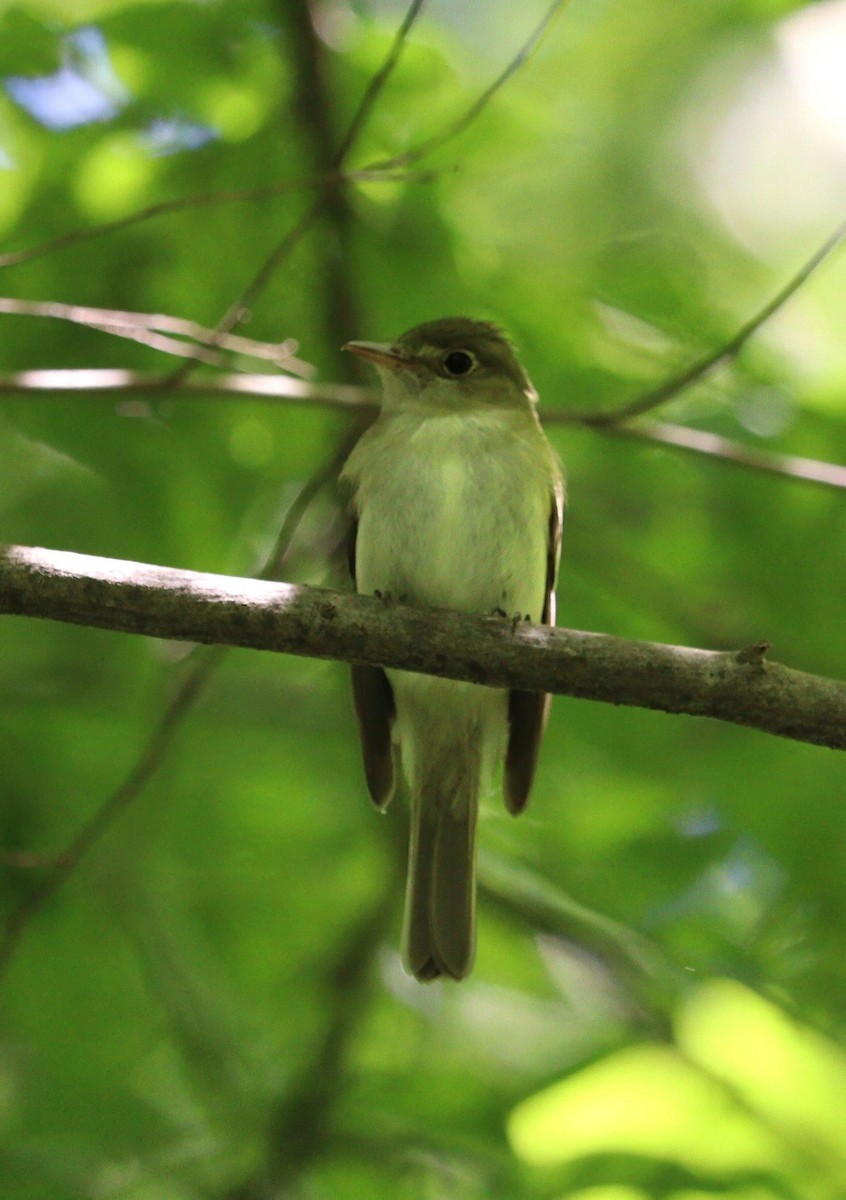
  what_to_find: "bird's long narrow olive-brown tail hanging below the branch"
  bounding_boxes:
[403,745,480,982]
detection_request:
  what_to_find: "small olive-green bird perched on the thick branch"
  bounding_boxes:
[341,317,564,980]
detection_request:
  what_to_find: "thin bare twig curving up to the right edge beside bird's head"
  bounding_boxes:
[576,222,846,425]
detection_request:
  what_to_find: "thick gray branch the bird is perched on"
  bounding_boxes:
[0,546,846,750]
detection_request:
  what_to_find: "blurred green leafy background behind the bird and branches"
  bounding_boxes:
[0,0,846,1200]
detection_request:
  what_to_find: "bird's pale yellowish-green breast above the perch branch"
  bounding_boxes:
[356,413,551,620]
